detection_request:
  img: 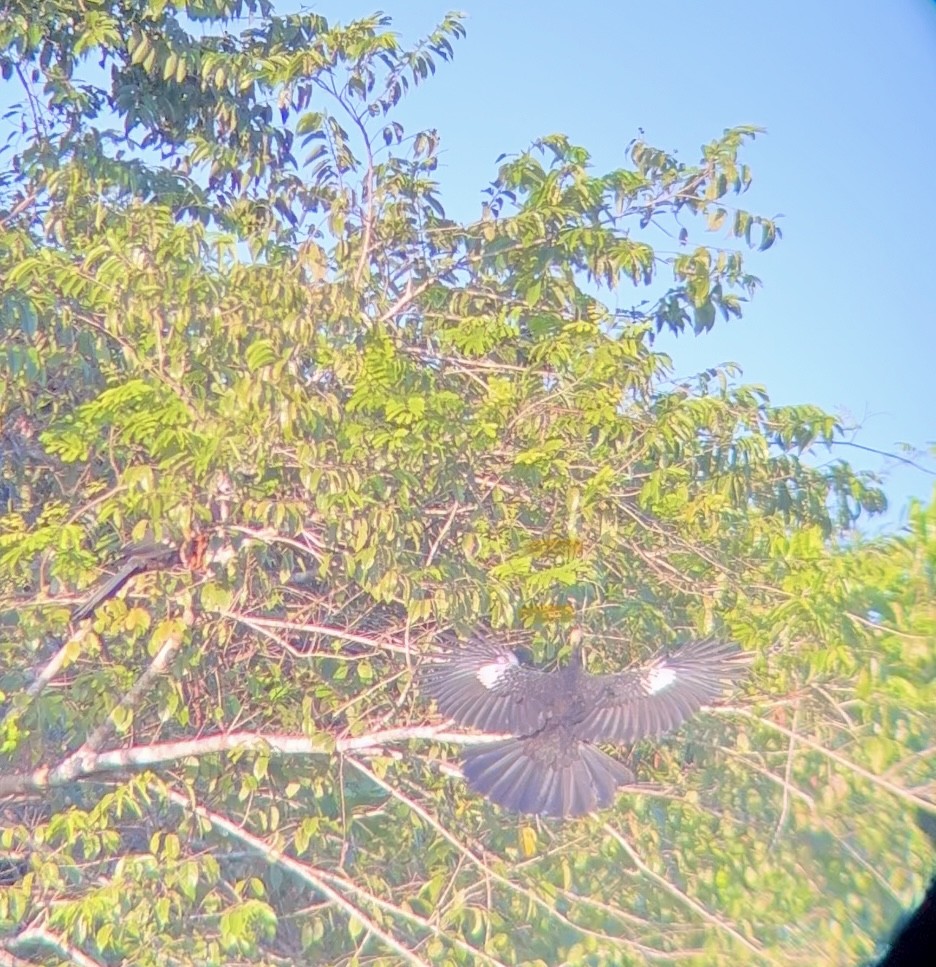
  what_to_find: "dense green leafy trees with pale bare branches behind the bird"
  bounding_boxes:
[0,0,936,964]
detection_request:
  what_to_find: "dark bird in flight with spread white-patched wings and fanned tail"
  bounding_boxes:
[420,636,746,818]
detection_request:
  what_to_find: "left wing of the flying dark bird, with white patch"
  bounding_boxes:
[420,638,555,735]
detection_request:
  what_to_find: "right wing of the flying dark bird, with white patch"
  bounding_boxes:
[575,641,747,742]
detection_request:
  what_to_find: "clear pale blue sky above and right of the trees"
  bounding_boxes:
[304,0,936,531]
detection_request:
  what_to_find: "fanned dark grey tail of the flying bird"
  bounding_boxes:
[462,735,634,817]
